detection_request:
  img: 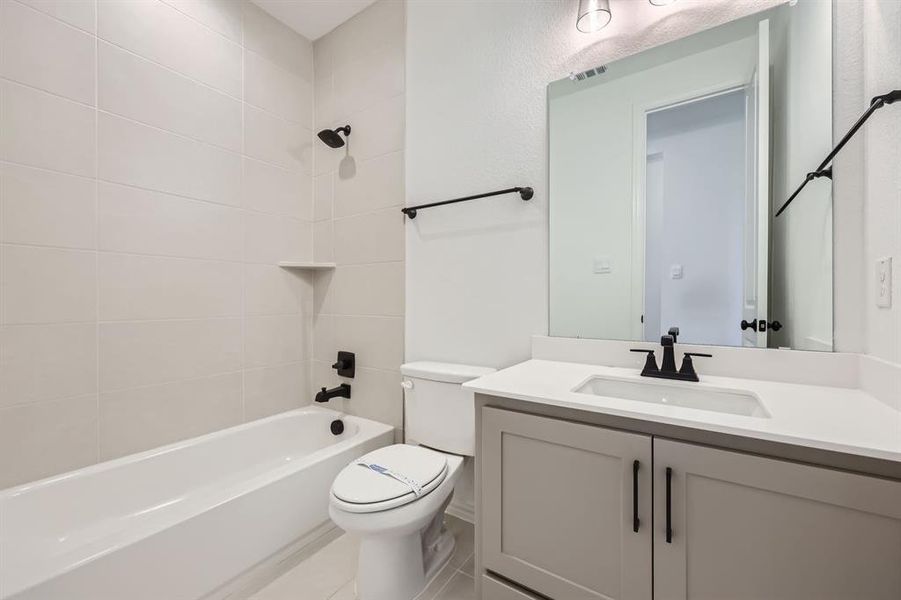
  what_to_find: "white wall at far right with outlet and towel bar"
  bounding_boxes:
[833,0,901,363]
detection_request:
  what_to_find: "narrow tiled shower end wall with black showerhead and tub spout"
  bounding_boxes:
[310,0,413,439]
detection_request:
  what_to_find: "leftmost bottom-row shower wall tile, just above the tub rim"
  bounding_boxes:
[0,396,97,489]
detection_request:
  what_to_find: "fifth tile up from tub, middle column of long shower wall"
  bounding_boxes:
[98,113,241,206]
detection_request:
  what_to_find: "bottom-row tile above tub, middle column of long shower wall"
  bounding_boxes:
[99,373,243,460]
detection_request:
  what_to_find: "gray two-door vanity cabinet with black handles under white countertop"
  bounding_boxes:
[478,407,901,600]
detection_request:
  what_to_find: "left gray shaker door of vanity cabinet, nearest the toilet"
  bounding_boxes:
[479,407,652,600]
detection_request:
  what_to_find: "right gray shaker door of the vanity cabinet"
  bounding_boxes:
[654,438,901,600]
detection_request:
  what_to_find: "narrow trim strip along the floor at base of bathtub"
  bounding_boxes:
[201,521,343,600]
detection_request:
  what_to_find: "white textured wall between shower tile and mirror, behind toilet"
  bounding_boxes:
[406,0,781,366]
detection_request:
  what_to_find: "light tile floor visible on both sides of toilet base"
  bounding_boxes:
[250,516,475,600]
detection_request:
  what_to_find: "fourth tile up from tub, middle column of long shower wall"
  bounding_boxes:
[97,182,244,261]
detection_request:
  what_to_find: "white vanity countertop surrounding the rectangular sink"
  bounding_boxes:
[463,359,901,462]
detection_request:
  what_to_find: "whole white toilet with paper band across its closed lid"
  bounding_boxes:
[329,362,494,600]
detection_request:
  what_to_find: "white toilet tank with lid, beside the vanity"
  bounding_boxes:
[400,362,495,456]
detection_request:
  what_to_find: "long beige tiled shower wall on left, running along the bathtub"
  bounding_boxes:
[0,0,316,488]
